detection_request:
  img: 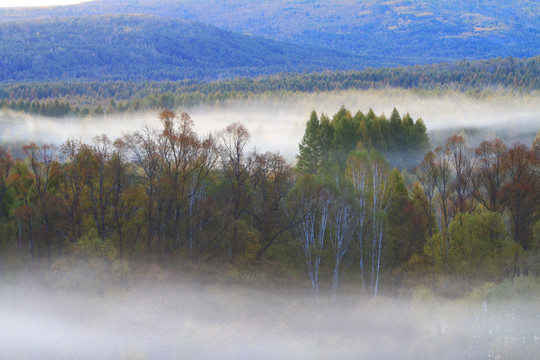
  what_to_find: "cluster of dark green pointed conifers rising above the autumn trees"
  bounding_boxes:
[297,107,430,169]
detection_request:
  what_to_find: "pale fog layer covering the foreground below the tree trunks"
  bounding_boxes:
[0,277,540,359]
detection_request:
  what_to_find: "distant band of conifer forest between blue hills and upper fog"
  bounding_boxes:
[0,57,540,116]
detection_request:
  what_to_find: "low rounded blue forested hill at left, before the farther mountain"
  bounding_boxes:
[0,15,360,82]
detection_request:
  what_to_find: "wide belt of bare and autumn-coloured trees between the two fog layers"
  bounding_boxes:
[0,109,540,299]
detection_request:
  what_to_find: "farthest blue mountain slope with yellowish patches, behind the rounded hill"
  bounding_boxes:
[0,0,540,68]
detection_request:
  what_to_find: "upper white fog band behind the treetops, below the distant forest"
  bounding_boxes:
[0,89,540,161]
